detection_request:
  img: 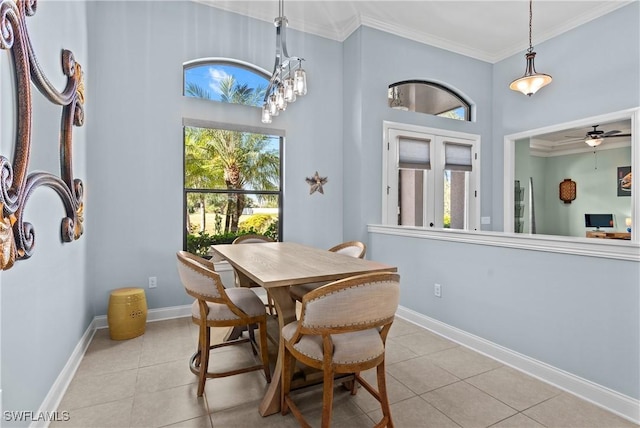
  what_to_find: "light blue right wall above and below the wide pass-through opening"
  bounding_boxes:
[368,2,640,400]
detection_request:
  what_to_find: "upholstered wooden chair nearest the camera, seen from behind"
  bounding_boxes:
[281,273,400,428]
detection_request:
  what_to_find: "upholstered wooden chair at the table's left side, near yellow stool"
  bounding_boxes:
[176,251,271,397]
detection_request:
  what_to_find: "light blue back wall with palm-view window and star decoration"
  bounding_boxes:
[86,1,343,314]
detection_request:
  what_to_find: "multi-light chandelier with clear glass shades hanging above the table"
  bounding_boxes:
[262,0,307,123]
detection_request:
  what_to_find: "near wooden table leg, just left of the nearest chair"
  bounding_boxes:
[259,287,296,416]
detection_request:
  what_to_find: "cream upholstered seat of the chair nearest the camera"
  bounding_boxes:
[282,321,384,364]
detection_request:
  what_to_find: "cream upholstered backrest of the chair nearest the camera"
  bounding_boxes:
[300,273,400,330]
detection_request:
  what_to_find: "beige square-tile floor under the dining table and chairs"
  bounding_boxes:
[51,318,637,428]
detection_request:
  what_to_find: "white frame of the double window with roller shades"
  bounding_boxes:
[381,121,481,230]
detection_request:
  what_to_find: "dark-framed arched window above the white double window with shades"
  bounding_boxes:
[388,80,471,121]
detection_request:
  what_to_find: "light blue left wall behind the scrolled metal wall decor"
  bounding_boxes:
[0,2,89,426]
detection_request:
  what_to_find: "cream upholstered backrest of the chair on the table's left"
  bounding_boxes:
[177,251,225,300]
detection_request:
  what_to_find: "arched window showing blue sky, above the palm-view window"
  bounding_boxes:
[183,58,269,107]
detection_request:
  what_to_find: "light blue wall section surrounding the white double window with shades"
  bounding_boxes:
[344,27,493,240]
